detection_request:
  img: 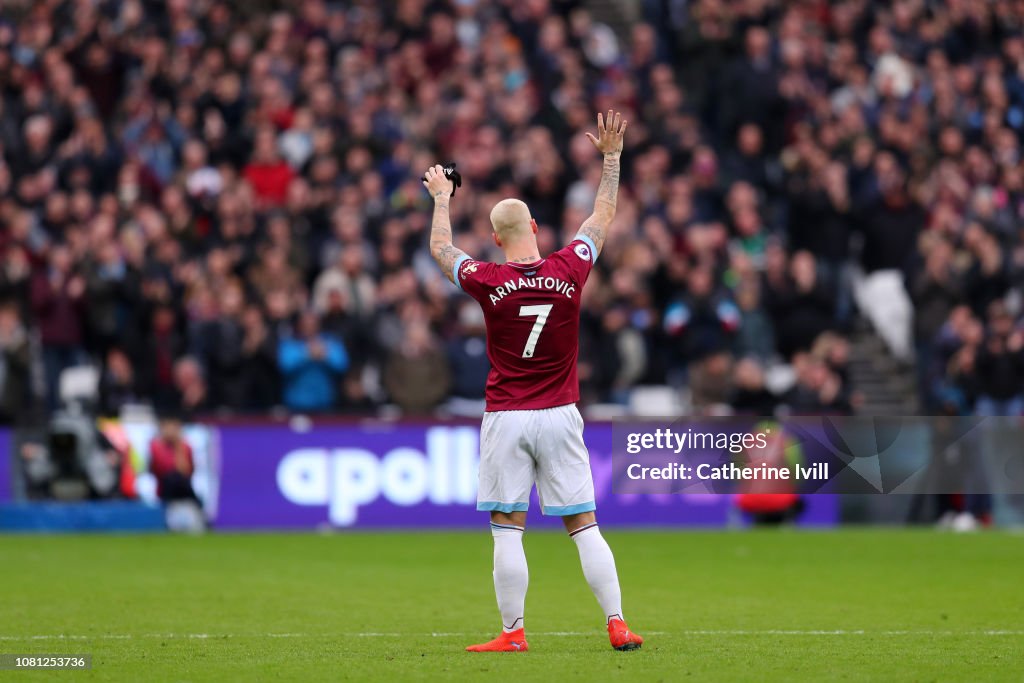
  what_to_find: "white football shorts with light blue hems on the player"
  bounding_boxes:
[476,403,596,516]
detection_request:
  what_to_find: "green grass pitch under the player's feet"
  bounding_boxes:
[0,525,1024,683]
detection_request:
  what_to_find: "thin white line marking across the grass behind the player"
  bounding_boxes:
[0,629,1024,641]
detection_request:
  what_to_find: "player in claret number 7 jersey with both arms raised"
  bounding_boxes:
[423,112,643,652]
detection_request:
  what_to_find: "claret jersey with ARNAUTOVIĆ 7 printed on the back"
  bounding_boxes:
[454,236,597,412]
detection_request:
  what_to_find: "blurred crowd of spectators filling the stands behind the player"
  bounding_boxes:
[0,0,1024,420]
